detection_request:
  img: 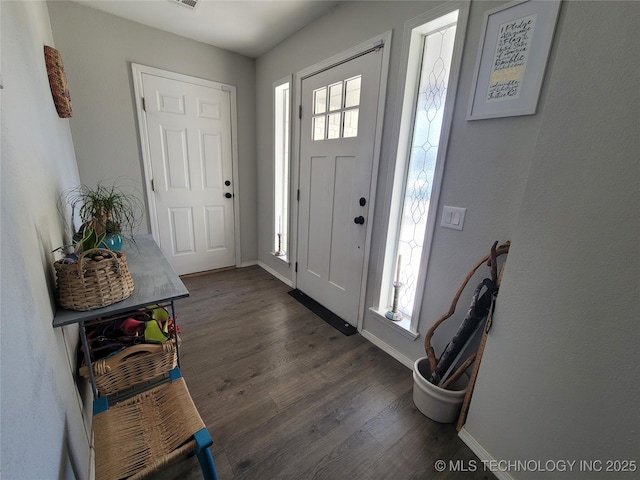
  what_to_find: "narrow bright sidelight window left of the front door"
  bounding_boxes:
[273,82,290,260]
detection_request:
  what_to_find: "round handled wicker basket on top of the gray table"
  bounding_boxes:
[53,248,133,311]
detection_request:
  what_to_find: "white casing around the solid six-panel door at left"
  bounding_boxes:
[131,63,242,267]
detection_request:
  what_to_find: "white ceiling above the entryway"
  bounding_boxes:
[69,0,340,57]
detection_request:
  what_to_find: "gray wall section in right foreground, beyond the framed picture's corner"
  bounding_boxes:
[466,2,640,479]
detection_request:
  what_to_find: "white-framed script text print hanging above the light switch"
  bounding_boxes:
[467,0,561,120]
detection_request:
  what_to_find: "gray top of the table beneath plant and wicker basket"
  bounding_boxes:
[53,235,189,327]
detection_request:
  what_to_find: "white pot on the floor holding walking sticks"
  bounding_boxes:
[413,357,469,423]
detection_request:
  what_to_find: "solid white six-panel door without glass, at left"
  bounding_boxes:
[136,72,236,275]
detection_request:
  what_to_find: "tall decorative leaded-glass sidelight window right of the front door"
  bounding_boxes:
[380,7,468,332]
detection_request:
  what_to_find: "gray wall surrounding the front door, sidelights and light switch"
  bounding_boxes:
[256,1,546,363]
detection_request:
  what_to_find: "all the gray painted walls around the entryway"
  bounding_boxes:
[0,2,640,479]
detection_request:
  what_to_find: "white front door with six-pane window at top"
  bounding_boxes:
[297,49,383,326]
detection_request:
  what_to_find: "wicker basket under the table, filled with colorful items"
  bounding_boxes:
[80,340,178,396]
